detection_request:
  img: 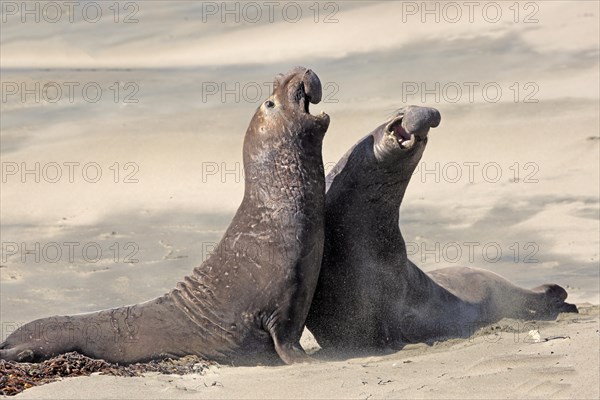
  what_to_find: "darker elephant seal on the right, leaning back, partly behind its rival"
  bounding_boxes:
[307,106,577,348]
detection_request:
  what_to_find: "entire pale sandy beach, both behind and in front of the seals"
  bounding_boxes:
[0,1,600,399]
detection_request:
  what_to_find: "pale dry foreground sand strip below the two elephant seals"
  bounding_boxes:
[11,305,600,399]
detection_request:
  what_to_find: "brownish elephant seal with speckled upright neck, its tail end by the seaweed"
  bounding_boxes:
[0,67,329,363]
